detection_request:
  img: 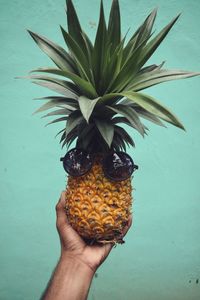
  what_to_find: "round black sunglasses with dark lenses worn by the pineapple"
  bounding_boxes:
[60,148,138,181]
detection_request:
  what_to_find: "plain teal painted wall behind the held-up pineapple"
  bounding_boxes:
[0,0,200,300]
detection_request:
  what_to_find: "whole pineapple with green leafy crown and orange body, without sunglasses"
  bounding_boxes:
[28,0,199,243]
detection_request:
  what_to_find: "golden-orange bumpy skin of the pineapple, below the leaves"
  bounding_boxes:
[66,159,133,243]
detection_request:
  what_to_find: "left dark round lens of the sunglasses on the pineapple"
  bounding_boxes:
[63,149,93,176]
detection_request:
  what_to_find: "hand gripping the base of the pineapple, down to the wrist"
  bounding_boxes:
[56,192,132,272]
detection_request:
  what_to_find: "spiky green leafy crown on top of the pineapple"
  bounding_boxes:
[24,0,200,152]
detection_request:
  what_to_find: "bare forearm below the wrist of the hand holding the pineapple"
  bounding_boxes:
[41,256,94,300]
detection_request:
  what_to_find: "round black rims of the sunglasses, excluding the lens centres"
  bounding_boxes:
[60,148,138,182]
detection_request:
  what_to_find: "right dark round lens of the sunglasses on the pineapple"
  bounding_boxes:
[103,152,136,181]
